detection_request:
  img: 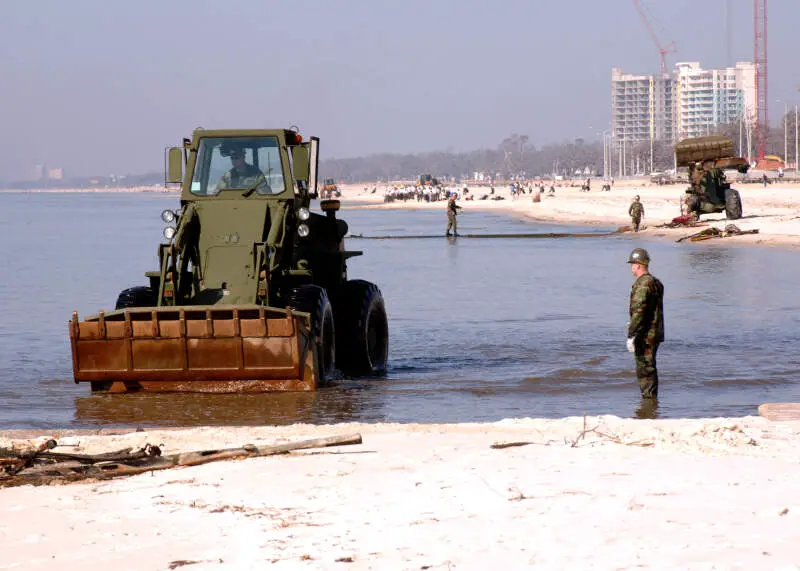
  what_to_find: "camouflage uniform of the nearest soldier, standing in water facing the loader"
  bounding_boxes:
[628,273,664,399]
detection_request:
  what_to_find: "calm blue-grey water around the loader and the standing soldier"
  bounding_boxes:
[0,193,800,428]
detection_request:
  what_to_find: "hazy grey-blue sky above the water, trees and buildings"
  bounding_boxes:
[0,0,800,181]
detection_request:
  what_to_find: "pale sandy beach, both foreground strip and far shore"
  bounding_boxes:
[0,184,800,571]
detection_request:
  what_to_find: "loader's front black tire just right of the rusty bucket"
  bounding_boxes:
[289,284,336,382]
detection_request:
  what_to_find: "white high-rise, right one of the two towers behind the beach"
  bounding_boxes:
[675,62,757,138]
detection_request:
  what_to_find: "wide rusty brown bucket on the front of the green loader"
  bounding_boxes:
[69,306,318,393]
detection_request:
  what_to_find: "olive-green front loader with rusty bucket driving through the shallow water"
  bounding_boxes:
[69,129,389,392]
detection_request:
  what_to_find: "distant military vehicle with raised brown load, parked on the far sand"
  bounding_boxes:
[675,136,749,220]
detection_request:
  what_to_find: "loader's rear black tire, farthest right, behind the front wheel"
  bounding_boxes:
[335,280,389,377]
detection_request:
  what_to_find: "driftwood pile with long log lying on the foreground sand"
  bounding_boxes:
[0,434,362,487]
